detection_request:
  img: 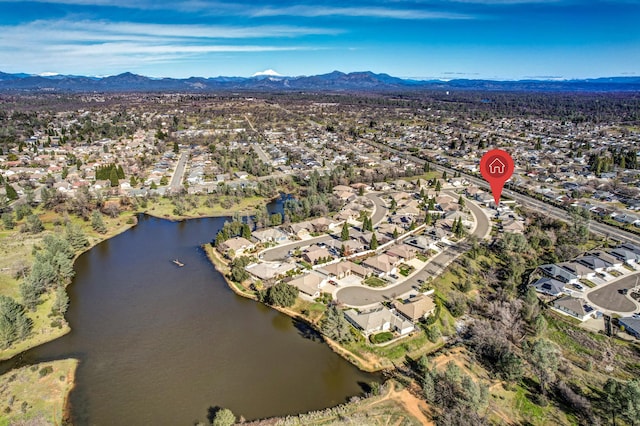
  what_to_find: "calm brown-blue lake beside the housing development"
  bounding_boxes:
[3,216,377,425]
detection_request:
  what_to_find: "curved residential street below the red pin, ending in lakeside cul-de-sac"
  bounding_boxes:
[335,196,491,307]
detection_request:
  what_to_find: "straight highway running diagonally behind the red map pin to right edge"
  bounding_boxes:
[366,141,640,245]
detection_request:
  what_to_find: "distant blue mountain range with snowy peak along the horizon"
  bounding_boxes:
[0,71,640,92]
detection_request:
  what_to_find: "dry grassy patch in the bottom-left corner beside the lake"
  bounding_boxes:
[0,359,78,426]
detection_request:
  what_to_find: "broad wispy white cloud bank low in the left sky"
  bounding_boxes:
[0,20,320,73]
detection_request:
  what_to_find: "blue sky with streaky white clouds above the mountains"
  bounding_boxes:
[0,0,640,79]
